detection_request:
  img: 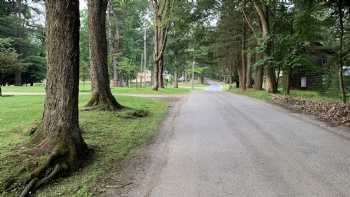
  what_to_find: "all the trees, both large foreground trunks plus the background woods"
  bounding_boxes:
[0,0,350,196]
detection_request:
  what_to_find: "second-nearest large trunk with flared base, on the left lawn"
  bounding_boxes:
[87,0,122,110]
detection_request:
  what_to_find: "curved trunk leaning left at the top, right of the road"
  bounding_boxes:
[254,2,277,93]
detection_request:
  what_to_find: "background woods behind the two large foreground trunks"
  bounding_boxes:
[1,0,349,101]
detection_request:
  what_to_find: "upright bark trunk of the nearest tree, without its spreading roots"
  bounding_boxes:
[43,0,87,162]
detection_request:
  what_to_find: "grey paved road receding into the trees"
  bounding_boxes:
[105,82,350,197]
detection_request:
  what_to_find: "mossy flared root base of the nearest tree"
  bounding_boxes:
[0,127,91,197]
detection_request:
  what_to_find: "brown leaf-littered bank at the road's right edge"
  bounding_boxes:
[272,95,350,127]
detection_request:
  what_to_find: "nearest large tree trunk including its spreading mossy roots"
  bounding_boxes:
[14,0,88,196]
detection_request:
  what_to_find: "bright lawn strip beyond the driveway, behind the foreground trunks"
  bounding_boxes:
[2,83,207,95]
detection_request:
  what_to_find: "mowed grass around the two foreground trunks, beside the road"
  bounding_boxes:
[0,95,167,197]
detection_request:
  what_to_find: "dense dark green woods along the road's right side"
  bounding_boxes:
[212,0,349,102]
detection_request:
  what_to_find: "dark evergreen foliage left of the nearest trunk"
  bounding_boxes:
[0,0,46,84]
